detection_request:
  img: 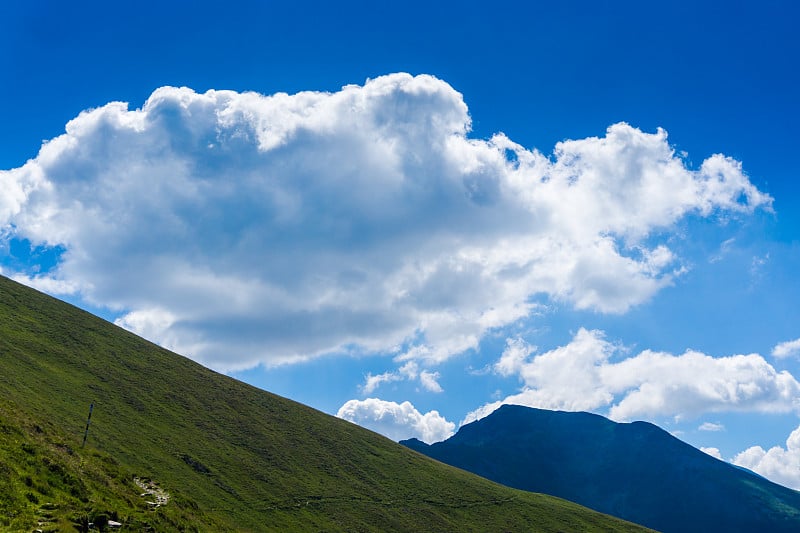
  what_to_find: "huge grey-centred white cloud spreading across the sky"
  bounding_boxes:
[0,74,771,368]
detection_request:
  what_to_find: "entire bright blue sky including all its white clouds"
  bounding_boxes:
[0,1,800,487]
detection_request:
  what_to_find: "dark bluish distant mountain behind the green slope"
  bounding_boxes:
[401,405,800,533]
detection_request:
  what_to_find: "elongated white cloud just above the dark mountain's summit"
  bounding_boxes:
[464,328,800,424]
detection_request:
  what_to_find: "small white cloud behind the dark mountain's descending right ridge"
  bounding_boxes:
[733,427,800,490]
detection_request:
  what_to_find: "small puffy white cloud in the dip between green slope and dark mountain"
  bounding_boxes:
[336,398,455,444]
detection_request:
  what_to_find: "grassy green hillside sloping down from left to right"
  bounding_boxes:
[0,277,643,531]
